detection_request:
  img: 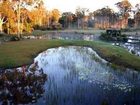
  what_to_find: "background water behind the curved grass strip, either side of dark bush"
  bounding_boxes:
[26,32,140,56]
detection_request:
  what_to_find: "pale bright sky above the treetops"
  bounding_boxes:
[45,0,140,13]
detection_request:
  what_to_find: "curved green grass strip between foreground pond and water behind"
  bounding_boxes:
[0,39,140,70]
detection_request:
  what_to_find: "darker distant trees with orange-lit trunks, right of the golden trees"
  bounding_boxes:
[60,0,140,29]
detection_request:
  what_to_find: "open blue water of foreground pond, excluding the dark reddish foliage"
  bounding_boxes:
[32,46,140,105]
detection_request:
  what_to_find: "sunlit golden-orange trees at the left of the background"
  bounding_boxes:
[0,0,60,34]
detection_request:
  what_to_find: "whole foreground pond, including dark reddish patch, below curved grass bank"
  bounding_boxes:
[0,46,140,105]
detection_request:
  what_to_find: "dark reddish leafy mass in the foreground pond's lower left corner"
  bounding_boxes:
[0,64,46,105]
